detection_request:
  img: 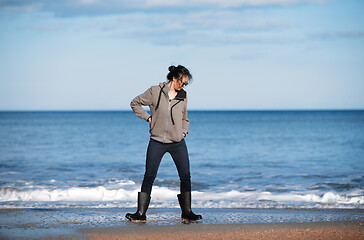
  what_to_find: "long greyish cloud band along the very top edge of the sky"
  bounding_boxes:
[0,0,328,17]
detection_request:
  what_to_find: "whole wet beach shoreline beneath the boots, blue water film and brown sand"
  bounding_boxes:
[0,208,364,239]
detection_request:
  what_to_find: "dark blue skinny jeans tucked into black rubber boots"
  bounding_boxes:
[141,139,191,195]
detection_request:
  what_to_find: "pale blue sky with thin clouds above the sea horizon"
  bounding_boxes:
[0,0,364,110]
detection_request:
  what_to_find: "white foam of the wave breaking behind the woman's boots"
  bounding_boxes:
[0,186,364,208]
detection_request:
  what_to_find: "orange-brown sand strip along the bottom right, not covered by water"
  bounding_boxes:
[82,222,364,240]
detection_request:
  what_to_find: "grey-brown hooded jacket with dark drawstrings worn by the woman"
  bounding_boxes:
[130,83,189,143]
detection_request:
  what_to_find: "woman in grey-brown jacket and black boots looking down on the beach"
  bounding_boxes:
[125,65,202,221]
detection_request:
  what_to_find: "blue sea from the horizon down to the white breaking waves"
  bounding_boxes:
[0,111,364,209]
